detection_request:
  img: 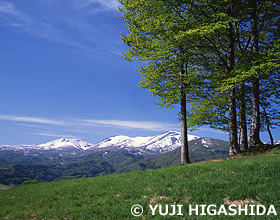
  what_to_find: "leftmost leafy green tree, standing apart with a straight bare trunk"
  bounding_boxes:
[120,0,211,164]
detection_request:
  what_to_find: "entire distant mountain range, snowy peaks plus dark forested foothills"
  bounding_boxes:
[0,131,232,185]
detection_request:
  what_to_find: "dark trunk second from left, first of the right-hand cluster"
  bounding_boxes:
[227,6,240,156]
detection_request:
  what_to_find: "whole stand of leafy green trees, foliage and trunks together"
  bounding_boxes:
[120,0,280,160]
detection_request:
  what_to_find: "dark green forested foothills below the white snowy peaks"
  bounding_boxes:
[0,138,228,186]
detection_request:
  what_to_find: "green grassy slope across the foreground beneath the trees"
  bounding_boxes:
[0,146,280,220]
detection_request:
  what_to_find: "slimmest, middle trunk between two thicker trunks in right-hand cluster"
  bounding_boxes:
[239,83,248,151]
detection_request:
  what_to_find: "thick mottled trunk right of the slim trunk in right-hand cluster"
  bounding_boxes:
[248,0,262,148]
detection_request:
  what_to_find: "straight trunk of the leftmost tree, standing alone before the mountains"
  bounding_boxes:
[180,60,191,165]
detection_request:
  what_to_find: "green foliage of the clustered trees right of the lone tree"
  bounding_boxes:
[184,1,280,139]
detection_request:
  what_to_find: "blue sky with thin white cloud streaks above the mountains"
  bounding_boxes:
[0,0,280,144]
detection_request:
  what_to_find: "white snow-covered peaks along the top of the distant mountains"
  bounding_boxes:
[0,131,199,153]
